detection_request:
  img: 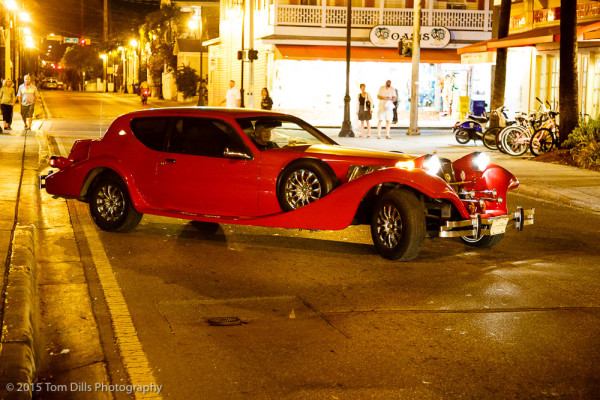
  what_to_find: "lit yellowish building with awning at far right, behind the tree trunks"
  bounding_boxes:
[458,0,600,118]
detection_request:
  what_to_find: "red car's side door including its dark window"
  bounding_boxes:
[156,117,260,216]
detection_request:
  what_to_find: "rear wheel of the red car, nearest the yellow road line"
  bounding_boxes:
[88,174,144,232]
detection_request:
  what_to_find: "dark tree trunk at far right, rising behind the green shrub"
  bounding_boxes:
[558,0,579,143]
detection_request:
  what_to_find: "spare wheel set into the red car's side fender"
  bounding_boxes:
[277,160,334,211]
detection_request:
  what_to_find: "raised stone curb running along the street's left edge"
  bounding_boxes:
[0,130,42,400]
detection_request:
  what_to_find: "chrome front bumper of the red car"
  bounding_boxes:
[440,207,535,238]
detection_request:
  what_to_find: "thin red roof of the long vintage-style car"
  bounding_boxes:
[124,107,287,118]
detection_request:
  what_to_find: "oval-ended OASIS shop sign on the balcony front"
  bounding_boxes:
[369,25,450,48]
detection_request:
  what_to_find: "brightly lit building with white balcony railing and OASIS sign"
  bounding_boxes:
[204,0,492,125]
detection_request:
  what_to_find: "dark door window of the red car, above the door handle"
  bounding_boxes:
[167,118,244,157]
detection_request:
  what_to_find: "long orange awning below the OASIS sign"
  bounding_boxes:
[275,45,460,64]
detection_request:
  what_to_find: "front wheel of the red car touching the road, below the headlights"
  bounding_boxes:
[371,189,426,261]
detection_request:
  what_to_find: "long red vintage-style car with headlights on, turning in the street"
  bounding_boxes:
[40,108,533,260]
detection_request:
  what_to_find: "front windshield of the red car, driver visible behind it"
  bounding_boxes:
[236,116,337,148]
